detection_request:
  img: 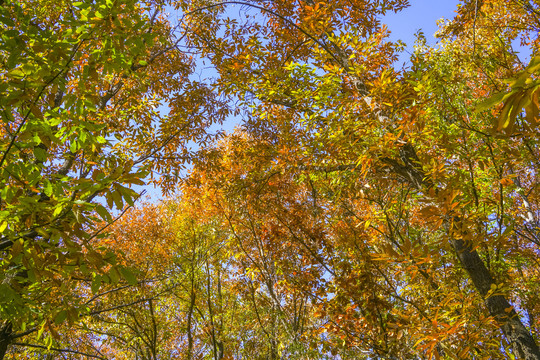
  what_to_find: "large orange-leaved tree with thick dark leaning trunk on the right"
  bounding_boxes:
[178,1,540,359]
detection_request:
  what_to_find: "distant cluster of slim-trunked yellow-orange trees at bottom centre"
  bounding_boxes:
[24,194,334,360]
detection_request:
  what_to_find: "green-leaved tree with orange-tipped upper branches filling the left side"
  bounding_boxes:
[0,0,226,357]
